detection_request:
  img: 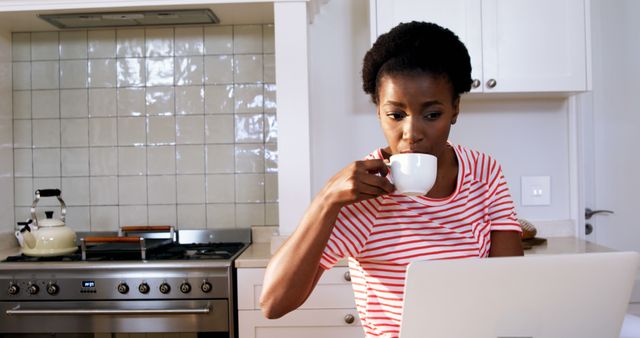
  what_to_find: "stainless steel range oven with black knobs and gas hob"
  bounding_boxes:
[0,229,251,338]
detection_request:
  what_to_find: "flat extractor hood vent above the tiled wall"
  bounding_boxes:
[38,9,220,29]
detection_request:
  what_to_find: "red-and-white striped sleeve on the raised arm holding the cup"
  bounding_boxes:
[320,201,374,270]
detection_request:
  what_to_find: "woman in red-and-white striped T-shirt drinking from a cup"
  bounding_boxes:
[261,22,522,337]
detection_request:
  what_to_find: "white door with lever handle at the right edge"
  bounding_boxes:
[578,0,640,251]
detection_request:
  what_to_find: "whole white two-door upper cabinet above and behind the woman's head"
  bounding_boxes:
[370,0,590,93]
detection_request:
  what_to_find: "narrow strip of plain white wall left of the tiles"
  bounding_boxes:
[0,32,13,232]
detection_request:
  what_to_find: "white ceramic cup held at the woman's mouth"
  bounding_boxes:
[389,153,438,196]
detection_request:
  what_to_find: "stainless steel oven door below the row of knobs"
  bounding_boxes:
[0,299,229,333]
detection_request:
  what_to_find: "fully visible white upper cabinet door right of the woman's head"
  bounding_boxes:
[482,0,587,93]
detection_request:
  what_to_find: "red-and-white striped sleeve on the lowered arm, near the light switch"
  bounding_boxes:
[487,159,522,232]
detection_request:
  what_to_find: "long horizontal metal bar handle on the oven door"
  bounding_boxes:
[6,305,211,315]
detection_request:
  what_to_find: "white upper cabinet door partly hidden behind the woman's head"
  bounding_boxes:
[371,0,482,92]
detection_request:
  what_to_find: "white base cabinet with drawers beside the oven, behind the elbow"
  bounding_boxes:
[238,267,364,338]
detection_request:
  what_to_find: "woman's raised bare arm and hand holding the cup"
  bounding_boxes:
[260,160,395,318]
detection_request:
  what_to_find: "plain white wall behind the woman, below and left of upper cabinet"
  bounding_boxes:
[309,0,570,226]
